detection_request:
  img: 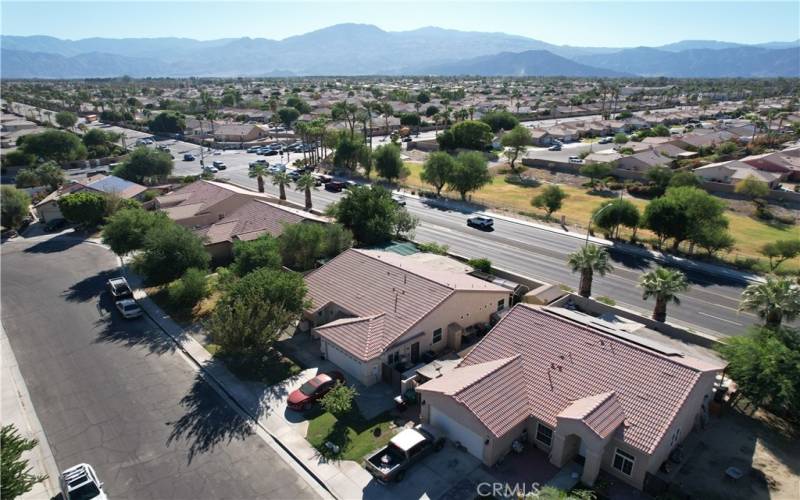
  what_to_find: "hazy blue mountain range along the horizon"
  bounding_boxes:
[0,24,800,78]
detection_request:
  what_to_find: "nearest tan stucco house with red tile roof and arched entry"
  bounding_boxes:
[417,304,724,488]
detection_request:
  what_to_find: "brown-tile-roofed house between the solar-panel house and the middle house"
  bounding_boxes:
[155,180,330,262]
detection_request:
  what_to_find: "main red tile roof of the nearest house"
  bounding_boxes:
[438,304,722,453]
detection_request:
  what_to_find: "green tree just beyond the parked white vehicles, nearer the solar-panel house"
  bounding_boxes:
[102,208,171,257]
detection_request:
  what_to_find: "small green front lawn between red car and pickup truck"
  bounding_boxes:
[306,408,394,462]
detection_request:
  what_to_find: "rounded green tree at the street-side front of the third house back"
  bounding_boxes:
[133,223,211,285]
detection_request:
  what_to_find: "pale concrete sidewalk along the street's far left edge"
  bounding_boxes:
[0,325,60,500]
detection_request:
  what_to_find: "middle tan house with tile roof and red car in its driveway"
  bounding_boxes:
[305,249,511,385]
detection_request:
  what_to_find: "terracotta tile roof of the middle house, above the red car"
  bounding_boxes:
[305,249,508,361]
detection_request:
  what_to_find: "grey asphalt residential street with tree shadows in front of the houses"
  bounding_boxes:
[2,233,317,499]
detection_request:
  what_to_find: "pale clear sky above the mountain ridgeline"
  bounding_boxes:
[0,0,800,47]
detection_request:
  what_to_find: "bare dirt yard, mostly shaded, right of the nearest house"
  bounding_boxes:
[675,409,800,500]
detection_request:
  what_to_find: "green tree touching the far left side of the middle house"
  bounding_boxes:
[278,224,353,271]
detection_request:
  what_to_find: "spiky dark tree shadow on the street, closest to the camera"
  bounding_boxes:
[167,373,253,463]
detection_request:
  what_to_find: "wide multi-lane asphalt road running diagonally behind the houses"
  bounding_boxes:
[166,151,757,336]
